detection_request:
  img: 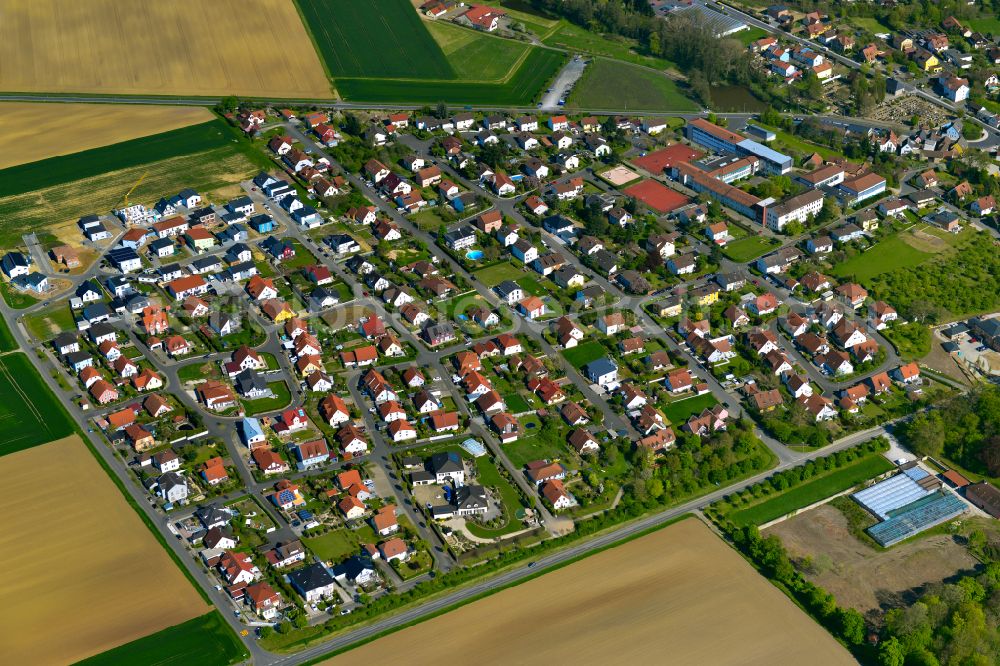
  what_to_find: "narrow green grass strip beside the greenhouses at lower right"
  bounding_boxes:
[729,453,893,527]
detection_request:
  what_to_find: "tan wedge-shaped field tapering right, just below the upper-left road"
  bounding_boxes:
[0,102,213,169]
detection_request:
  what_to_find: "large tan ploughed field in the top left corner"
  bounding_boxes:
[0,0,332,99]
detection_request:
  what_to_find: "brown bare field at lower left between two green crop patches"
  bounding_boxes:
[0,435,209,664]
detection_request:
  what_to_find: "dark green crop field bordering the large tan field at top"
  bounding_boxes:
[295,0,455,79]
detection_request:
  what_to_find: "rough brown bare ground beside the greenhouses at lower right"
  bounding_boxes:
[765,500,980,613]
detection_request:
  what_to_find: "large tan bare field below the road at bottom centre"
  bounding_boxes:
[336,519,855,666]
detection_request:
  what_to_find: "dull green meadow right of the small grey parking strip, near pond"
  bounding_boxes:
[566,58,698,111]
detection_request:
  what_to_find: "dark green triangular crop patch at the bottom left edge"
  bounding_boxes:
[77,611,250,666]
